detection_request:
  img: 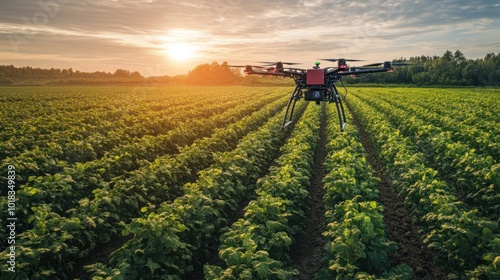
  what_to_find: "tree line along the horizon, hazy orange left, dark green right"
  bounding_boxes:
[0,50,500,86]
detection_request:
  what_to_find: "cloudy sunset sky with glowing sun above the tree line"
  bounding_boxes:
[0,0,500,76]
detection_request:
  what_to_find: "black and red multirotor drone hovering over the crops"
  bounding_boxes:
[228,58,413,131]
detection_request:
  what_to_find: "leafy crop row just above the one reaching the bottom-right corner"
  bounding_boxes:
[352,91,500,224]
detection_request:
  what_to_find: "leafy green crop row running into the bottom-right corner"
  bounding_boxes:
[349,91,500,279]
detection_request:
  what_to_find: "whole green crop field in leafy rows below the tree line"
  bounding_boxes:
[0,86,500,280]
